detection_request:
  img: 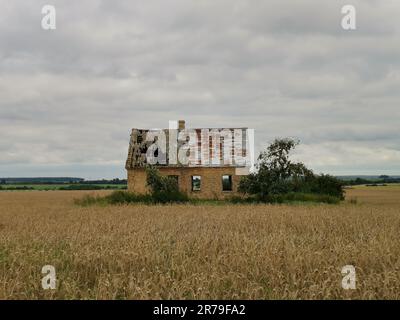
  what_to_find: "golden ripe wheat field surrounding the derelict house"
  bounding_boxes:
[0,187,400,299]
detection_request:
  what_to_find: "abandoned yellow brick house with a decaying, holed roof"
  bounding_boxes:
[126,120,248,199]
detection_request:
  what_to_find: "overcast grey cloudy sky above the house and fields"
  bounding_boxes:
[0,0,400,178]
